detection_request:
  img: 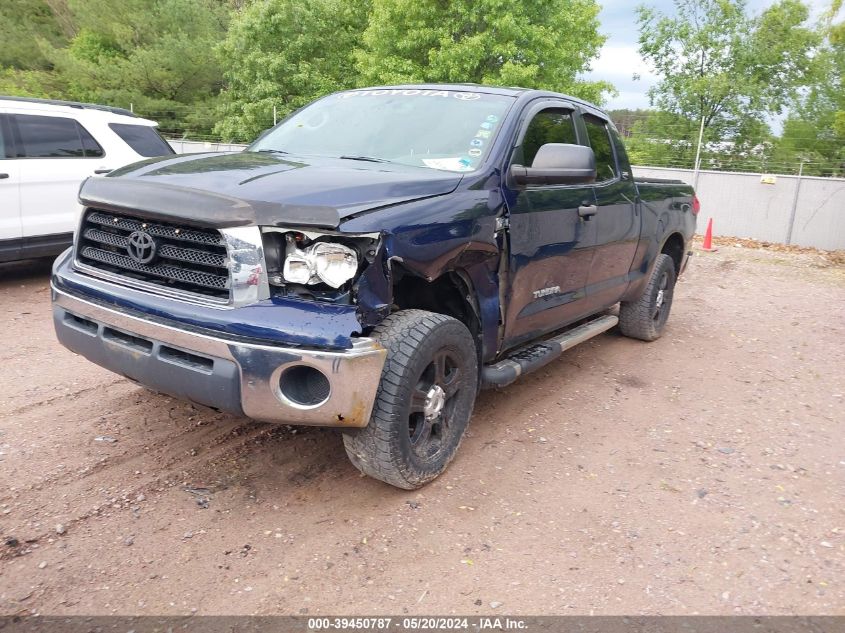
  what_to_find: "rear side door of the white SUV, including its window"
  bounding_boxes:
[11,113,104,238]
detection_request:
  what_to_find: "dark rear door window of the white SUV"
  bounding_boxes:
[13,114,105,158]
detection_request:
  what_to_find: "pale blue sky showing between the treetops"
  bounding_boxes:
[587,0,830,110]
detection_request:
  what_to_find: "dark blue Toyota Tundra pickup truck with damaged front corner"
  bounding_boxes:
[52,85,698,489]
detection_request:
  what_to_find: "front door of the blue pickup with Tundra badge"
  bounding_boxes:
[502,100,596,350]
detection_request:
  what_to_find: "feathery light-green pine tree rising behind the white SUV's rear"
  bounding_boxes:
[54,0,229,134]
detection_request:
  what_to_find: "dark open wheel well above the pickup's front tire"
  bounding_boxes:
[393,268,481,348]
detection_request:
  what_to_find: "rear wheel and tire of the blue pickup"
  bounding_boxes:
[619,253,676,341]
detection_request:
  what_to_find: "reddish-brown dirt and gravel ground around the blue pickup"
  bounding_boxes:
[0,246,845,615]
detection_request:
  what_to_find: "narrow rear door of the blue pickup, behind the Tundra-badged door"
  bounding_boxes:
[582,113,640,311]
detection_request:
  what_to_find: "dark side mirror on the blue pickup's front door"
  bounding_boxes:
[511,143,596,185]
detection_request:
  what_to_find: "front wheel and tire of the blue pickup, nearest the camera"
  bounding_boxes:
[343,310,478,490]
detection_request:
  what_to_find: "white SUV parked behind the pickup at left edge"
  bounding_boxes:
[0,96,174,262]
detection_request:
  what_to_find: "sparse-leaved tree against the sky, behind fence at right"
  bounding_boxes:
[638,0,819,153]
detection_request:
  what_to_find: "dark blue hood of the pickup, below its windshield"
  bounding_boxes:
[79,152,462,228]
